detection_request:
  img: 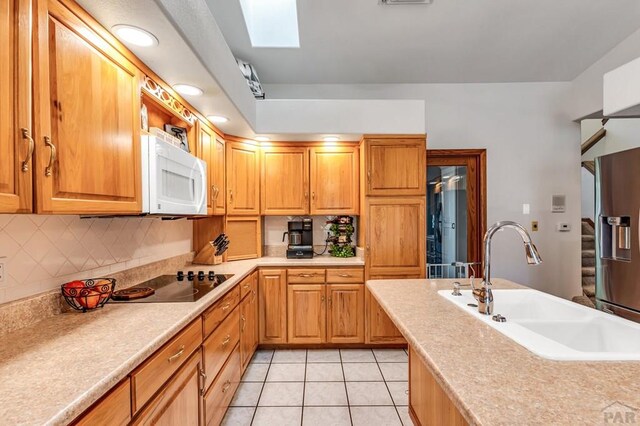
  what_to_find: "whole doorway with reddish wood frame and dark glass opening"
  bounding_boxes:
[427,149,487,278]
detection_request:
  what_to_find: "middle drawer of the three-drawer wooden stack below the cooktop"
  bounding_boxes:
[202,307,240,389]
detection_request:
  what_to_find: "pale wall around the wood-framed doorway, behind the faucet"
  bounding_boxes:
[266,83,581,297]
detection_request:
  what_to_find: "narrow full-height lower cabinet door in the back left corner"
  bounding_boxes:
[258,269,287,344]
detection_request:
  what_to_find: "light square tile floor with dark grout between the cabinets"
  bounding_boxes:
[223,349,413,426]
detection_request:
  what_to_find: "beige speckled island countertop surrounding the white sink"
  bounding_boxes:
[367,279,640,425]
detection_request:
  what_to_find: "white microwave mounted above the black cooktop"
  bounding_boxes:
[141,135,207,216]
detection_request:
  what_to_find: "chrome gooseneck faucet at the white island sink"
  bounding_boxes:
[471,221,542,315]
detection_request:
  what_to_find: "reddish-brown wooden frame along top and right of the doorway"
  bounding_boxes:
[427,149,487,272]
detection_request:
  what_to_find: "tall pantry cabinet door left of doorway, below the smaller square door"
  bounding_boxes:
[365,197,426,278]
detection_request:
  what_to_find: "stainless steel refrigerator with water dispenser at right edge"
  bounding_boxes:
[595,148,640,322]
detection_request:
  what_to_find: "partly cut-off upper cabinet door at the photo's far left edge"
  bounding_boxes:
[0,0,34,213]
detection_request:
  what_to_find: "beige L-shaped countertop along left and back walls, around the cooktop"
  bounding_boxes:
[0,256,364,425]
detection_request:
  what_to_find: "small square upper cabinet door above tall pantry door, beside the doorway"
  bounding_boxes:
[365,138,427,196]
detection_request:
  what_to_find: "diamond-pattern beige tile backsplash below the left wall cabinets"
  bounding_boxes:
[0,215,192,303]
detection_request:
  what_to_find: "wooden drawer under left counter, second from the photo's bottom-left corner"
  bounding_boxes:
[131,318,202,412]
